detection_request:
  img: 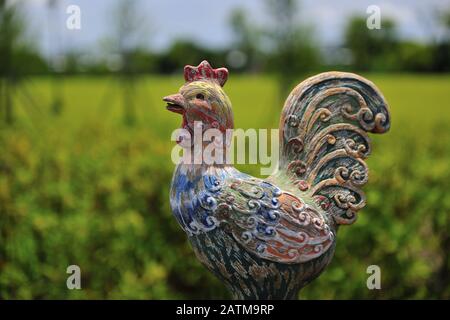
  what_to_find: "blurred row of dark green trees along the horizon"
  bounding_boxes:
[0,0,450,77]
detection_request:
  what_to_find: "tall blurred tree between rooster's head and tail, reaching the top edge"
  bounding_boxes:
[266,0,319,99]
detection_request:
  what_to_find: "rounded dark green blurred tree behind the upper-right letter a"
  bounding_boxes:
[345,17,398,70]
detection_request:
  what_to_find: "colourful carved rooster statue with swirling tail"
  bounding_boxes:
[163,61,390,299]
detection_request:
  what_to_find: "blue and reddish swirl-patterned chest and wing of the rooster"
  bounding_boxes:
[172,168,334,263]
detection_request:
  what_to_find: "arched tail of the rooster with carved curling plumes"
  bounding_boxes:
[279,72,390,224]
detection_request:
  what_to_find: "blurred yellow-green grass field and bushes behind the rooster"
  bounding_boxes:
[0,74,450,299]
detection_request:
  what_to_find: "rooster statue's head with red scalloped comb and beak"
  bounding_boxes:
[163,61,233,132]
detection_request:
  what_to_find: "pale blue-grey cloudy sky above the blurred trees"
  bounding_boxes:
[15,0,450,52]
